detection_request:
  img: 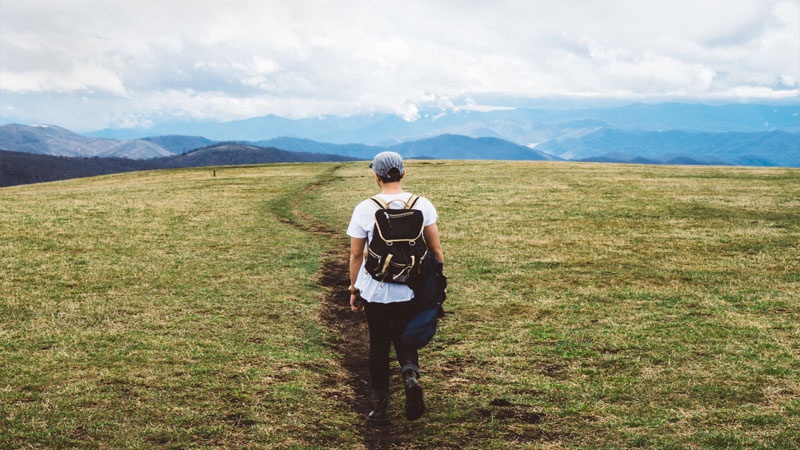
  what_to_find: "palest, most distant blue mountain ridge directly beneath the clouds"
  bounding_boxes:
[87,103,800,146]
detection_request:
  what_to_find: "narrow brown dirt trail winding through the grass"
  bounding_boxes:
[292,170,416,449]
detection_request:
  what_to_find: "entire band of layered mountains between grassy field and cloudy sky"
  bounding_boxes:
[0,103,800,183]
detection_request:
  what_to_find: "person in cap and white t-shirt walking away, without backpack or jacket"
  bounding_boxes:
[347,152,444,423]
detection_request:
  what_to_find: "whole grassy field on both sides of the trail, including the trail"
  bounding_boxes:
[0,161,800,449]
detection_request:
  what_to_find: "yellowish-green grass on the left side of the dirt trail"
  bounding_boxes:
[0,166,356,448]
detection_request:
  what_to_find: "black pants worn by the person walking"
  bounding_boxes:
[364,301,419,394]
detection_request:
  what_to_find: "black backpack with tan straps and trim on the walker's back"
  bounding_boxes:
[364,195,428,284]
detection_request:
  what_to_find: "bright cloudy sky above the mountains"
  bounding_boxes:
[0,0,800,131]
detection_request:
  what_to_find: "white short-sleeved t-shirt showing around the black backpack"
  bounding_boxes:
[347,192,438,303]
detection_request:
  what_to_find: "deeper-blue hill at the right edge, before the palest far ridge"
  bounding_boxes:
[537,129,800,167]
